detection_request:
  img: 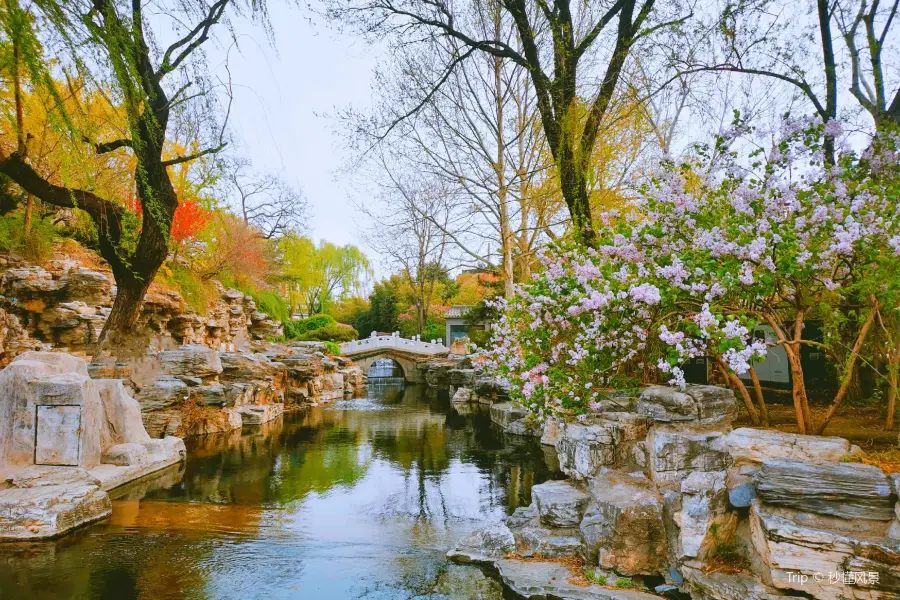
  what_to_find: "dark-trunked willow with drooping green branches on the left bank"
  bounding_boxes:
[0,0,262,354]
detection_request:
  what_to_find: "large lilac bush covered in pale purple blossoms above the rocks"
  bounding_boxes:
[488,123,900,432]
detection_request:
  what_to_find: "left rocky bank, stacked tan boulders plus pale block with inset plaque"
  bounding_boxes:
[0,248,366,541]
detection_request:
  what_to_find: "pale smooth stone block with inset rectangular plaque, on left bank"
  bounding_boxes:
[0,352,185,540]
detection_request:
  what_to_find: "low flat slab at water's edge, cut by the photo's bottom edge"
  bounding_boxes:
[494,559,659,600]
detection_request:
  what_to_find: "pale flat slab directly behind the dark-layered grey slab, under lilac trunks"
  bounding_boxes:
[722,427,851,463]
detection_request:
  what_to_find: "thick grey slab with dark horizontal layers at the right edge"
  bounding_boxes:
[754,459,894,521]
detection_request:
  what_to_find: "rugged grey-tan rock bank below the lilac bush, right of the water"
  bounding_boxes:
[426,360,900,600]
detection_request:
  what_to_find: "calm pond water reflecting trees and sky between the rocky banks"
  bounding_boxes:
[0,379,554,600]
